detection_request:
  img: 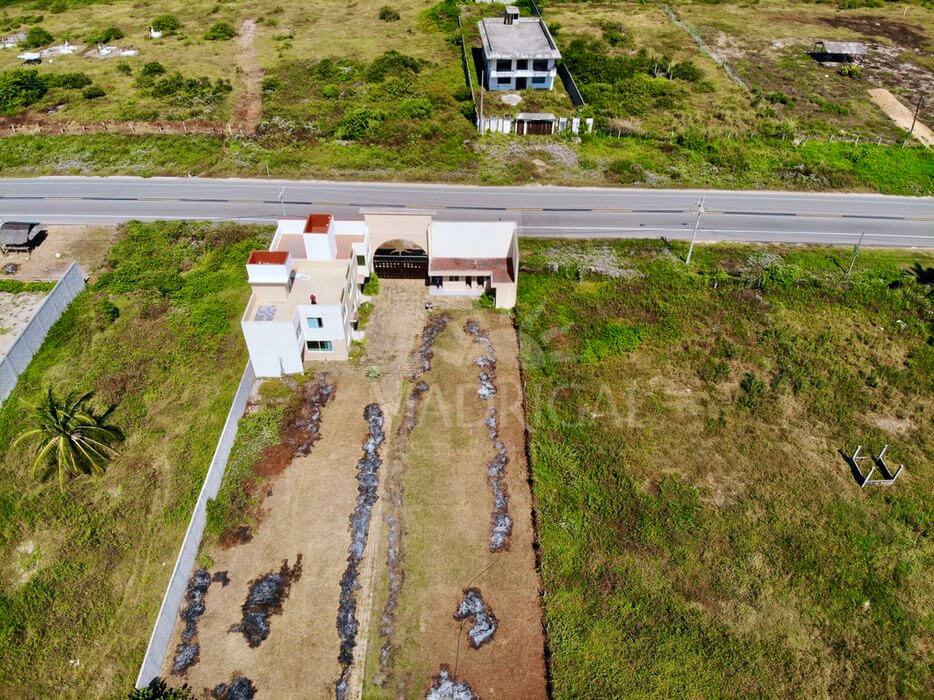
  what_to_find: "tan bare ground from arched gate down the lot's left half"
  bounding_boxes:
[163,281,425,698]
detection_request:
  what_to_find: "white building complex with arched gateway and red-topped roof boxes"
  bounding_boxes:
[240,212,519,377]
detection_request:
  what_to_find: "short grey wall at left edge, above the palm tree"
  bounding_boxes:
[0,262,84,404]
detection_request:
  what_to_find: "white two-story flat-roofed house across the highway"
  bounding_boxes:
[478,6,561,90]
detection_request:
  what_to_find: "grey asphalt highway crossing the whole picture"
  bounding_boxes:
[0,177,934,248]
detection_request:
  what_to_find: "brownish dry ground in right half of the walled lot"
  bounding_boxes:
[366,311,546,698]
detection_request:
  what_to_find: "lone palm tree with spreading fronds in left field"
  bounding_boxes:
[11,386,123,488]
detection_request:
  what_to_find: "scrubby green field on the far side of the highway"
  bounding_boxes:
[0,0,934,194]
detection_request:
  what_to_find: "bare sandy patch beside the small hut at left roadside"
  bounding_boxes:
[0,226,117,280]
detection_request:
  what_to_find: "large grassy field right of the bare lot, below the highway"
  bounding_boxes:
[518,241,934,698]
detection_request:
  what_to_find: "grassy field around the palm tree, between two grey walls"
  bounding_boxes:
[0,217,268,697]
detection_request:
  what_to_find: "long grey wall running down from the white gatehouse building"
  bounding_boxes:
[136,361,256,688]
